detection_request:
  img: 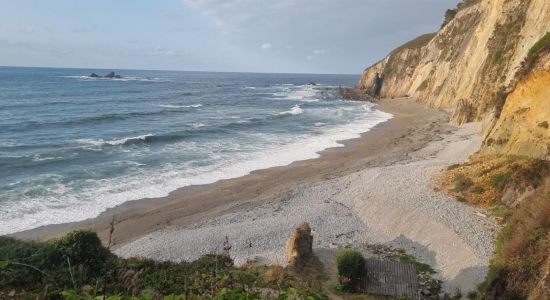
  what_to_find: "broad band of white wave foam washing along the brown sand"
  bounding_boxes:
[0,103,392,235]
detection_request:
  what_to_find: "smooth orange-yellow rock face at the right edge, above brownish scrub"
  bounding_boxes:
[482,58,550,160]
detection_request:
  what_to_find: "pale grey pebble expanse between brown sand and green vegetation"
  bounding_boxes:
[116,123,498,293]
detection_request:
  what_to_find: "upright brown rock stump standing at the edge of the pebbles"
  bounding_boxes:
[286,223,313,271]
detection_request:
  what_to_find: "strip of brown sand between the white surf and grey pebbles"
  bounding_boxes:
[9,99,444,248]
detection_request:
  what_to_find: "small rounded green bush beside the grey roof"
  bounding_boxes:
[336,249,365,292]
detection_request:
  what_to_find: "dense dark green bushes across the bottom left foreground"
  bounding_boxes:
[0,231,326,300]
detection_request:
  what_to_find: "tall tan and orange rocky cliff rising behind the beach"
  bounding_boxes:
[358,0,550,159]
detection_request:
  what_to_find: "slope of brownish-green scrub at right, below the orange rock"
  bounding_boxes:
[439,156,550,299]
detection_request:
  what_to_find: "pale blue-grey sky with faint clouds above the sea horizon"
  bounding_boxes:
[0,0,458,74]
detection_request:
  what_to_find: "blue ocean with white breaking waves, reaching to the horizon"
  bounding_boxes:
[0,67,391,234]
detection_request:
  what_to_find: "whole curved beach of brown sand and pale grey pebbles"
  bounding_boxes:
[16,99,497,292]
